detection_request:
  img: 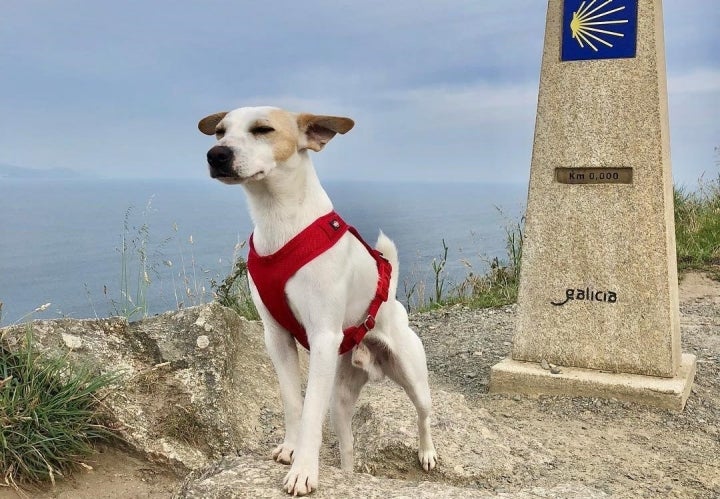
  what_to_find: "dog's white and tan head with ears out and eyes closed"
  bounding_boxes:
[198,107,355,184]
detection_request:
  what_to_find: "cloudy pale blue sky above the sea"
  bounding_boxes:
[0,0,720,186]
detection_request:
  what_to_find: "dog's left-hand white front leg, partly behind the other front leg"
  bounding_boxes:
[263,318,303,464]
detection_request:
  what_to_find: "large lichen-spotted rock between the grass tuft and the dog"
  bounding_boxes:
[2,304,281,472]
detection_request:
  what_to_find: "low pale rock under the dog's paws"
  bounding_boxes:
[177,381,607,499]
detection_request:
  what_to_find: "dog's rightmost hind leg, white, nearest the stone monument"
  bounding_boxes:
[383,326,437,471]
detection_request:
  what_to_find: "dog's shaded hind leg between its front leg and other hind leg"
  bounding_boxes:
[330,353,368,471]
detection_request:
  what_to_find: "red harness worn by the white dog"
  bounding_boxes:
[247,211,392,354]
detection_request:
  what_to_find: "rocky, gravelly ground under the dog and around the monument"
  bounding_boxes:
[0,274,720,499]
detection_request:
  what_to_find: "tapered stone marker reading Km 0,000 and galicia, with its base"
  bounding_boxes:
[490,0,695,410]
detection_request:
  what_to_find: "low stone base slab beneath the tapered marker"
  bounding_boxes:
[490,354,695,411]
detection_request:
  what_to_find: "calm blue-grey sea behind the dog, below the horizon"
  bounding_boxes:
[0,178,527,326]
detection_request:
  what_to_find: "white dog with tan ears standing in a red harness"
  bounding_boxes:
[198,107,437,495]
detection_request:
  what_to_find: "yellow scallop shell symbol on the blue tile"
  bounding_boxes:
[570,0,629,52]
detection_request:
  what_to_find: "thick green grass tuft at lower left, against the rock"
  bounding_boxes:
[0,328,116,488]
